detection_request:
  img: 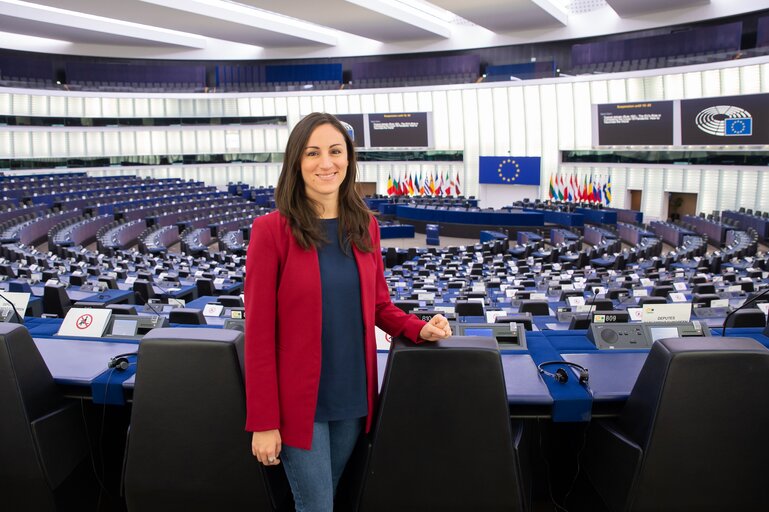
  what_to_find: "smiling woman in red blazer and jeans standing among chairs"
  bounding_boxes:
[245,113,451,512]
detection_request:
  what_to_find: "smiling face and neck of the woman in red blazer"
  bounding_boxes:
[301,124,347,217]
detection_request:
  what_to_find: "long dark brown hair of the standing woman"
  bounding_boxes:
[275,112,372,252]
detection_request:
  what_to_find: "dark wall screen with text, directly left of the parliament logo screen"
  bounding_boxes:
[596,101,673,146]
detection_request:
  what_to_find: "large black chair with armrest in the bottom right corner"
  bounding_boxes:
[584,337,769,512]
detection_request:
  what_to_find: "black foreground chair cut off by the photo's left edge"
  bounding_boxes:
[0,323,91,511]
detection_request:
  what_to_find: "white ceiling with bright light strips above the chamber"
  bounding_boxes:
[0,0,769,60]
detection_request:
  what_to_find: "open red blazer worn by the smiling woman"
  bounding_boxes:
[245,212,425,449]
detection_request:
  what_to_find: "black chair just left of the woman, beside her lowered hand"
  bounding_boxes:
[125,328,288,512]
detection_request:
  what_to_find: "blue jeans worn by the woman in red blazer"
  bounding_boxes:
[280,418,365,512]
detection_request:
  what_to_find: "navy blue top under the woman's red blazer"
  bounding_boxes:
[315,219,368,421]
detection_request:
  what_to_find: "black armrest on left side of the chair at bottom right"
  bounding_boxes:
[582,420,643,511]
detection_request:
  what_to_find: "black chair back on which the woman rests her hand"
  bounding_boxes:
[358,336,529,512]
